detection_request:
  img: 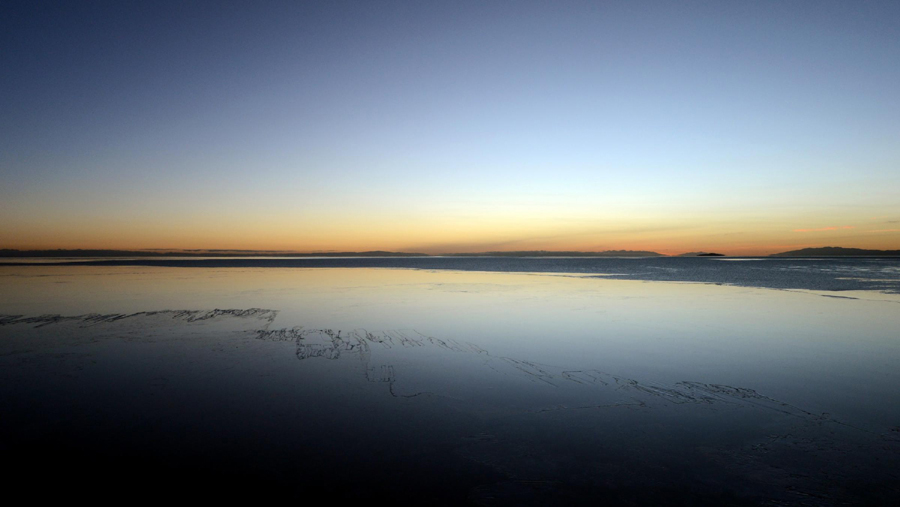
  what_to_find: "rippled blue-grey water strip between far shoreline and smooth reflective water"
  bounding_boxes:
[4,257,900,294]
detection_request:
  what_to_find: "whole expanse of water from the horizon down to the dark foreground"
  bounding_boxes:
[0,259,900,506]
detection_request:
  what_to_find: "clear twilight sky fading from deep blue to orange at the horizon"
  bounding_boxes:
[0,0,900,255]
